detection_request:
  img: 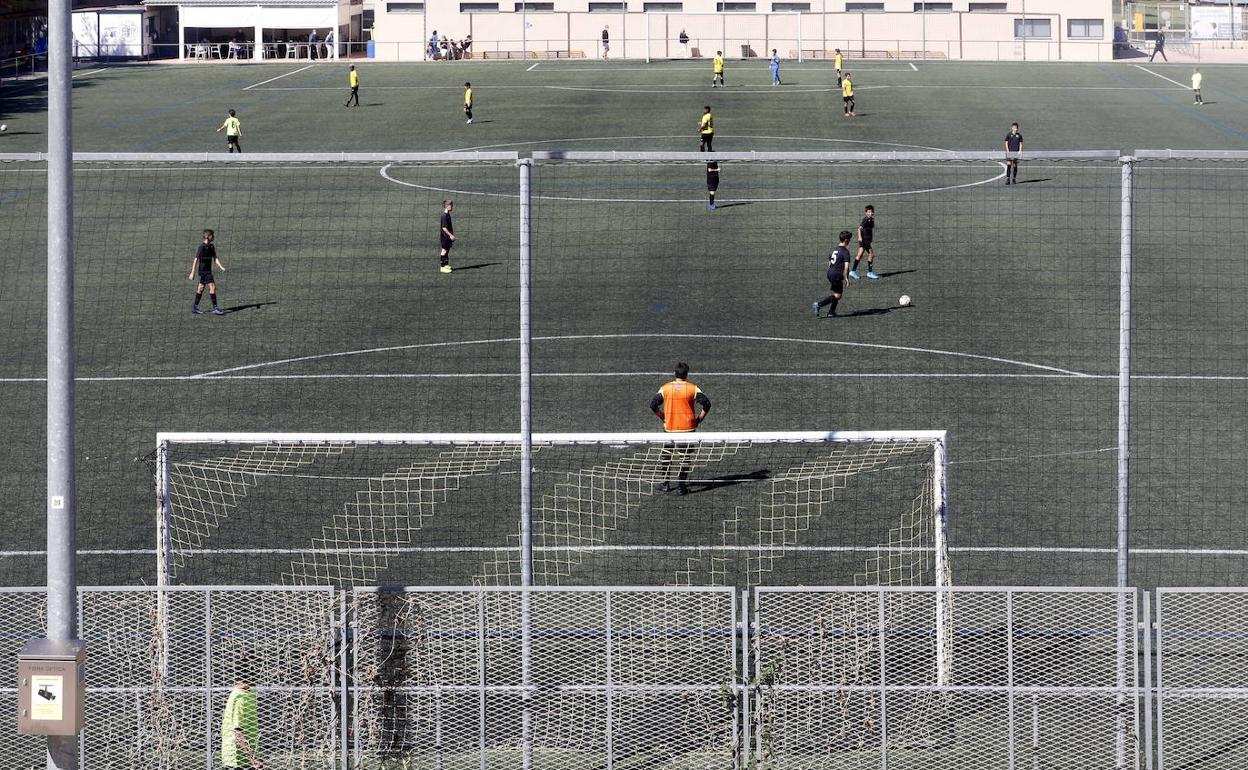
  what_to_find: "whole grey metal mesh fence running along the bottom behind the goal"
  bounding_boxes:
[0,587,1248,770]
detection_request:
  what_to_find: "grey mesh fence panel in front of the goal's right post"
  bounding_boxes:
[751,588,1141,770]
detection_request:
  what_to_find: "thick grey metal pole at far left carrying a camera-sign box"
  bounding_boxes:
[47,0,79,770]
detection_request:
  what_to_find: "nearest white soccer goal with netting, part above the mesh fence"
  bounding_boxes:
[152,431,950,588]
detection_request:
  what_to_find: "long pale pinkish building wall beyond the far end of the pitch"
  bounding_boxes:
[374,0,1113,61]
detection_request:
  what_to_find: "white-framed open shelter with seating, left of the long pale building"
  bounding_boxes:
[144,0,339,59]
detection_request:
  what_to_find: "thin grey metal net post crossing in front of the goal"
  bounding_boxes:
[517,158,533,770]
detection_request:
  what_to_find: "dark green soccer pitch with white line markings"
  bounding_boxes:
[0,61,1248,585]
